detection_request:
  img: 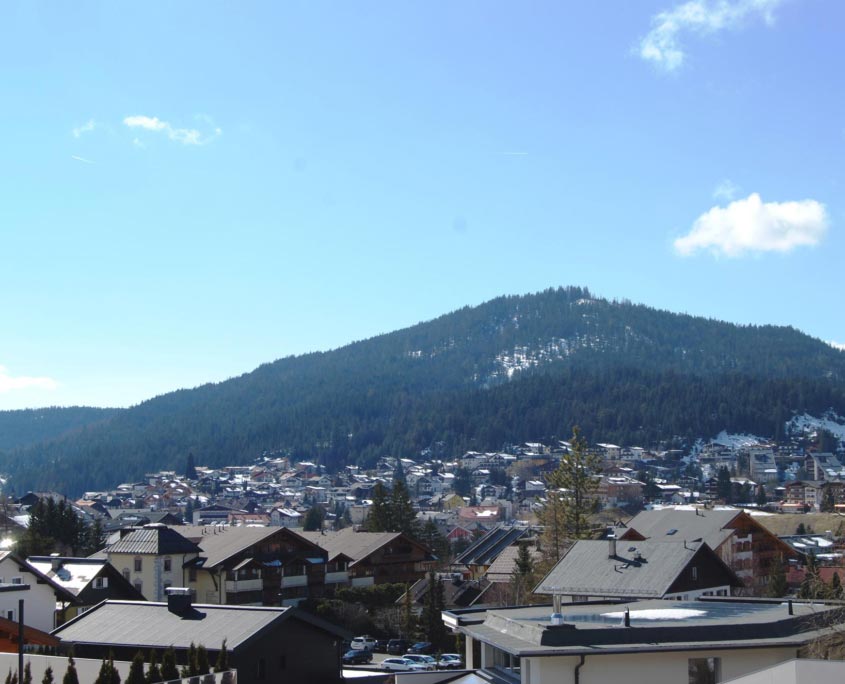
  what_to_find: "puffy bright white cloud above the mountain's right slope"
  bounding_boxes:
[674,192,828,257]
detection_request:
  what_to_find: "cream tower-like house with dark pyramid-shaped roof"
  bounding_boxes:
[105,523,200,601]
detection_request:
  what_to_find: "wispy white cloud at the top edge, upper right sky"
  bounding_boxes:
[638,0,782,71]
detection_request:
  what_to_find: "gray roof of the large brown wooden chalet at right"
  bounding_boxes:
[616,508,742,549]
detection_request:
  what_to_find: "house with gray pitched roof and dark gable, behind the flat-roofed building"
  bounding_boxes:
[534,538,742,602]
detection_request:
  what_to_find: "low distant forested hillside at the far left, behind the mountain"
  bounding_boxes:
[0,406,120,451]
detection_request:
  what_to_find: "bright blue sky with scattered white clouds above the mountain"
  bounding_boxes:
[0,0,845,409]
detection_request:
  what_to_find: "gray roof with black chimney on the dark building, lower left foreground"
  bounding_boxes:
[53,601,291,649]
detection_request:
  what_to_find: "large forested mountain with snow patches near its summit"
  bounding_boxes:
[0,288,845,493]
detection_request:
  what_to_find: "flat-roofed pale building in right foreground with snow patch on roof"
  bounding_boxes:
[442,598,845,684]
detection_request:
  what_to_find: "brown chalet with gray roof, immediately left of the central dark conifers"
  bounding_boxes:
[301,527,436,586]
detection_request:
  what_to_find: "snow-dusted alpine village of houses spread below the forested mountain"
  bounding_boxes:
[0,442,845,684]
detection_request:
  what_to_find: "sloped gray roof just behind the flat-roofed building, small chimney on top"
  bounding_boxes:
[534,540,732,598]
